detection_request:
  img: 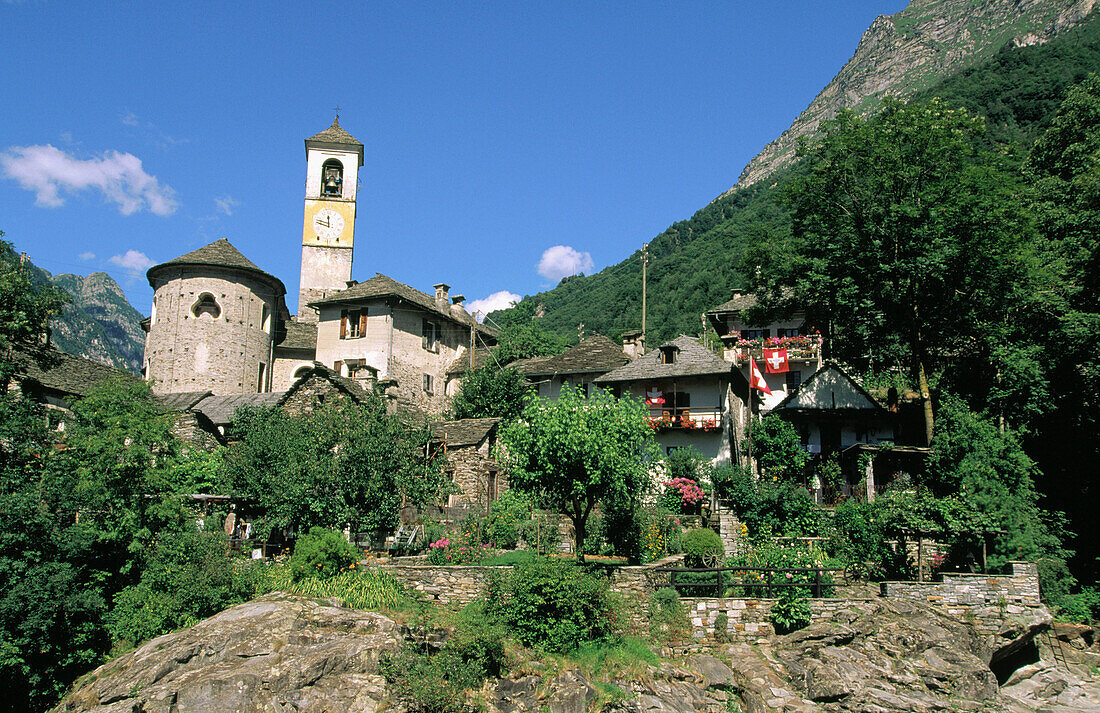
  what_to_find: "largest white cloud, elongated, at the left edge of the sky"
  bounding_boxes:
[0,144,179,216]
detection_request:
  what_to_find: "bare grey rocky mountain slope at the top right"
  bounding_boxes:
[727,0,1097,193]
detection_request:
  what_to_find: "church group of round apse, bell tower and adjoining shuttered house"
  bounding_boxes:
[143,121,496,414]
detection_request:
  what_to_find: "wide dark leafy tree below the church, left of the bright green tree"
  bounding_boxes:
[224,394,448,534]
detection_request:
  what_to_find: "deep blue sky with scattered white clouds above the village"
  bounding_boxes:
[0,0,906,314]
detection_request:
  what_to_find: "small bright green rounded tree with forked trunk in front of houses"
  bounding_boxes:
[502,388,659,560]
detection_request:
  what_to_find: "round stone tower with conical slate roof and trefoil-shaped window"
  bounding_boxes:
[144,239,286,395]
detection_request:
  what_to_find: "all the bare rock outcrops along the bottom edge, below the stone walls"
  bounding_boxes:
[56,593,1100,713]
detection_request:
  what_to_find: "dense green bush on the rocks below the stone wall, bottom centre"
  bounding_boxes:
[487,558,617,652]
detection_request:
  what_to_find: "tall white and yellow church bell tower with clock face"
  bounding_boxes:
[298,114,363,321]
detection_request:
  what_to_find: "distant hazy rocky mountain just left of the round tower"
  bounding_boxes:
[48,271,145,373]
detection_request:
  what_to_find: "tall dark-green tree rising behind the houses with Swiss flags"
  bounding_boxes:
[746,101,1036,441]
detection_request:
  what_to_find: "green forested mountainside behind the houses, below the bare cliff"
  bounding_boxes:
[490,13,1100,344]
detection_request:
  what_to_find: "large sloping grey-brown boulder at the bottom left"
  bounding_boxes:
[55,593,402,713]
